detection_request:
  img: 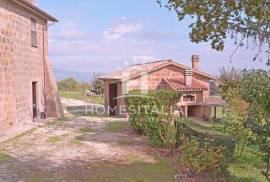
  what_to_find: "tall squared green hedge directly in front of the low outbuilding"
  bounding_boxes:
[126,90,181,147]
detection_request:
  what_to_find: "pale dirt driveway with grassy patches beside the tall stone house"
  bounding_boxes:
[0,117,175,182]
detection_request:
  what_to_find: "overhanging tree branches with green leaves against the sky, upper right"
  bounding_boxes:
[157,0,270,64]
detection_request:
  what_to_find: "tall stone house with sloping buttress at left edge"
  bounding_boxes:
[0,0,63,133]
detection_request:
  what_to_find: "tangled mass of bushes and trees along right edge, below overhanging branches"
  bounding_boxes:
[220,70,270,181]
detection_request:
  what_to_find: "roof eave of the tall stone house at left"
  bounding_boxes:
[12,0,58,22]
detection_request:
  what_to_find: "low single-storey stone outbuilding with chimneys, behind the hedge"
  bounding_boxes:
[100,55,224,120]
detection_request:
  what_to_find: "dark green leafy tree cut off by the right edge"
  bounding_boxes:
[242,70,270,181]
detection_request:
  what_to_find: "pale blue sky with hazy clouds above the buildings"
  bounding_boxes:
[37,0,268,75]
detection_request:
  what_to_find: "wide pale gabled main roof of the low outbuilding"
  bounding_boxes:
[100,60,217,80]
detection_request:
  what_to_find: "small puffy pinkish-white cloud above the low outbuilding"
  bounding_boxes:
[103,21,143,41]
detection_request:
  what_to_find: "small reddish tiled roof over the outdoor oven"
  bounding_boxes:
[163,78,207,91]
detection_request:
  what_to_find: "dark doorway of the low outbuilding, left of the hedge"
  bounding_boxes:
[109,83,117,116]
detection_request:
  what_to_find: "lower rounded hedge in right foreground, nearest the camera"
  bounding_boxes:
[176,119,235,173]
